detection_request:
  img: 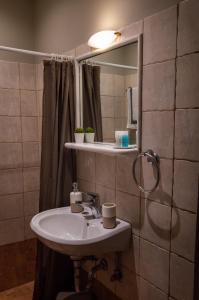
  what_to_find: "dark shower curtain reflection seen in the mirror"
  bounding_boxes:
[82,64,102,142]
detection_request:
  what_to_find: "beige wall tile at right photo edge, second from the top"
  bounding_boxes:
[176,53,199,108]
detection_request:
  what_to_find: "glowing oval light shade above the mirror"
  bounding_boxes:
[88,30,121,49]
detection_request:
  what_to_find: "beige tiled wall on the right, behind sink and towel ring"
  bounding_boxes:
[76,0,199,300]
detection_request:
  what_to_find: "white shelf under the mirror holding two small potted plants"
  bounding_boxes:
[64,143,138,155]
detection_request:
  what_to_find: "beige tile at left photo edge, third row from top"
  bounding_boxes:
[0,116,21,142]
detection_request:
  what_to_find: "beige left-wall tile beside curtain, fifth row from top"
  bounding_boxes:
[23,167,40,192]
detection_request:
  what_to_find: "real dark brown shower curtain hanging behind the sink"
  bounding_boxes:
[33,61,76,300]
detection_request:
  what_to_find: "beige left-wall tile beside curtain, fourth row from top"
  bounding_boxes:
[22,142,40,167]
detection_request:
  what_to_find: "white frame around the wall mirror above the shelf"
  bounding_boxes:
[75,34,143,152]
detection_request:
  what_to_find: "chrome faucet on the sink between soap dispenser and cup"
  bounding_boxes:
[82,192,101,219]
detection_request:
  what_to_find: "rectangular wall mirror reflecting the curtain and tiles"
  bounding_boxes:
[77,36,142,149]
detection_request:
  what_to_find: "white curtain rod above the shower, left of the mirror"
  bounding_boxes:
[0,46,73,59]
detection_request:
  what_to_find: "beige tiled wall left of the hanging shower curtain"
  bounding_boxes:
[0,61,43,246]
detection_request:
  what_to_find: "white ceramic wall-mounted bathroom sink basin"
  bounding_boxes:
[30,207,131,256]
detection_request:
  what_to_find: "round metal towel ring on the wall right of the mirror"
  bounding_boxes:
[132,149,160,194]
